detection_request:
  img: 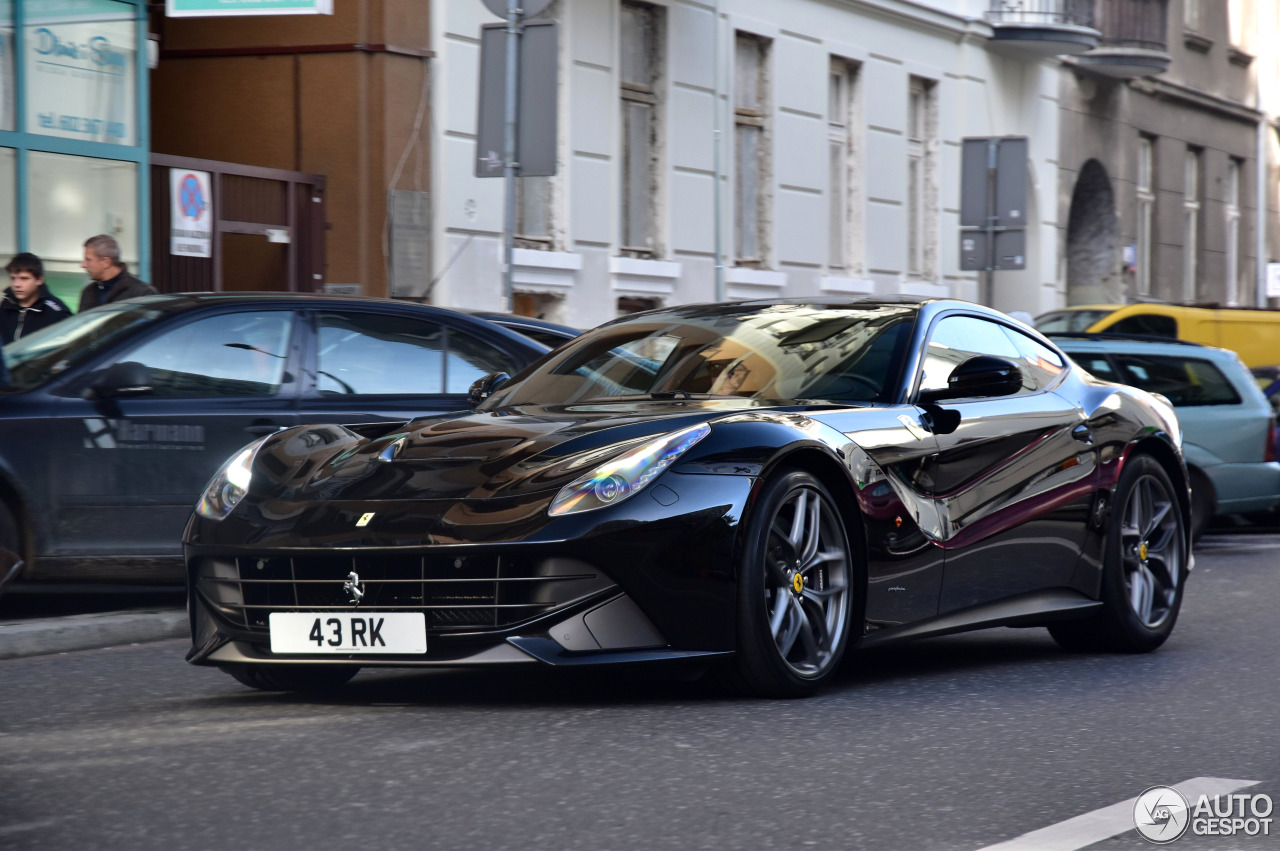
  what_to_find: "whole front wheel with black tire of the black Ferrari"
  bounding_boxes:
[730,470,863,697]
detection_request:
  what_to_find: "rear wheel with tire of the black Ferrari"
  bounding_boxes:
[1048,456,1188,653]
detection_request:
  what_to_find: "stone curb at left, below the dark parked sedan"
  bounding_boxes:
[0,609,191,659]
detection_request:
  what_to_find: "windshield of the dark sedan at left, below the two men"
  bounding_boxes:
[4,299,161,389]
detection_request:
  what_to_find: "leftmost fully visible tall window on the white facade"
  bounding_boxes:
[618,3,662,256]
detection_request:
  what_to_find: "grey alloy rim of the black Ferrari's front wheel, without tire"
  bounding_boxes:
[764,486,851,678]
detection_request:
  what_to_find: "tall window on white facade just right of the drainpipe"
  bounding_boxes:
[733,32,769,265]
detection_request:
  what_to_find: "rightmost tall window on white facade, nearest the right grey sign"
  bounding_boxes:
[906,77,938,279]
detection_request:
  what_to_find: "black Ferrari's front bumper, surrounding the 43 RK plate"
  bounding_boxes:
[186,473,753,667]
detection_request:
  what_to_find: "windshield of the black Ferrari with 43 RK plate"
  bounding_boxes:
[484,305,915,410]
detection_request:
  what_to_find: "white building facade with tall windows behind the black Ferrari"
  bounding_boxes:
[427,0,1065,328]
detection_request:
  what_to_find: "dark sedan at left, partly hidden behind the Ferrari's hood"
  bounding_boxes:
[0,293,548,584]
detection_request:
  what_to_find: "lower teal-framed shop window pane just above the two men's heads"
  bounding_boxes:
[27,151,138,292]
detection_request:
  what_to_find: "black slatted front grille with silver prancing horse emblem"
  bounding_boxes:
[196,550,612,632]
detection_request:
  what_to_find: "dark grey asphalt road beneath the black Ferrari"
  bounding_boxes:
[0,534,1280,851]
